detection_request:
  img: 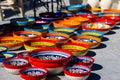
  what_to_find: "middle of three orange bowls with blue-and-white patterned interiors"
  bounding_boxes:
[42,32,70,43]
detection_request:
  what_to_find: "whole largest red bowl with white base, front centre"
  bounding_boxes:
[28,48,72,74]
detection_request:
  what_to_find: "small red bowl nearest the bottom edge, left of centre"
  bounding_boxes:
[19,67,48,80]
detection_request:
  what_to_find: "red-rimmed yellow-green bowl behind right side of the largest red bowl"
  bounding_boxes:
[60,42,89,55]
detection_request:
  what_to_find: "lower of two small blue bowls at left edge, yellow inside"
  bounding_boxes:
[0,52,16,66]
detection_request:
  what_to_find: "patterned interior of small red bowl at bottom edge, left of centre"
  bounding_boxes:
[21,68,47,76]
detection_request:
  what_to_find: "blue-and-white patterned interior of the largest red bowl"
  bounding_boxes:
[31,50,70,60]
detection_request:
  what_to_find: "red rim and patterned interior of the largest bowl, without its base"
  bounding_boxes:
[28,48,72,64]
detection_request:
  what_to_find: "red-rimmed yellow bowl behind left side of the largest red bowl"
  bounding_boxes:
[24,39,56,51]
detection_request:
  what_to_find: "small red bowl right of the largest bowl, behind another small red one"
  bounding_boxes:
[71,56,94,67]
